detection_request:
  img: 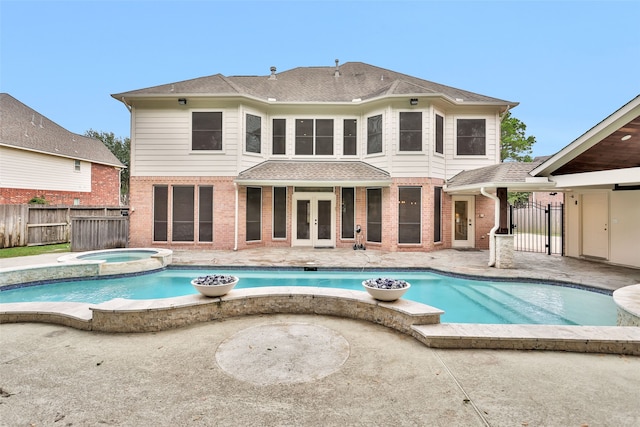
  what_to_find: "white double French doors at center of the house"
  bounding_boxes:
[292,193,336,248]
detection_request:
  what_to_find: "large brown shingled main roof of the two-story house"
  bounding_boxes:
[111,62,518,107]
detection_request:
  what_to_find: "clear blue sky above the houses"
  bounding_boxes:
[0,0,640,159]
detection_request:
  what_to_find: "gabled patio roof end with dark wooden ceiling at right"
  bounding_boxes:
[531,95,640,177]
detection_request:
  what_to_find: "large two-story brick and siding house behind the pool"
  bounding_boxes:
[112,61,517,251]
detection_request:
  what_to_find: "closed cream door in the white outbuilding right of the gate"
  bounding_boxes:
[582,193,609,259]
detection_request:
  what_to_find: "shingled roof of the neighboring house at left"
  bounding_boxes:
[0,93,124,167]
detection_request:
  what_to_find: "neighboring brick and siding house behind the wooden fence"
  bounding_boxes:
[0,93,124,206]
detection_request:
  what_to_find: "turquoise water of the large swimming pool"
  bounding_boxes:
[0,269,617,326]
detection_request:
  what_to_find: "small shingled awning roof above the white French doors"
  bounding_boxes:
[235,160,391,187]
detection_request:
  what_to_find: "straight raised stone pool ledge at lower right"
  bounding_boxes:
[412,323,640,356]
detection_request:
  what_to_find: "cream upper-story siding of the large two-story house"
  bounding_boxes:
[131,101,500,179]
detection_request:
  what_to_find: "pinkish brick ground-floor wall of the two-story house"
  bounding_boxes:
[130,177,494,252]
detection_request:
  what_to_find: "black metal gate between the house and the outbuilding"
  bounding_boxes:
[509,202,564,255]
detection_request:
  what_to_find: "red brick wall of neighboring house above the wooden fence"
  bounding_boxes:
[0,163,120,206]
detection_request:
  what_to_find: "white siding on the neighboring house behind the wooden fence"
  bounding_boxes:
[0,147,91,193]
